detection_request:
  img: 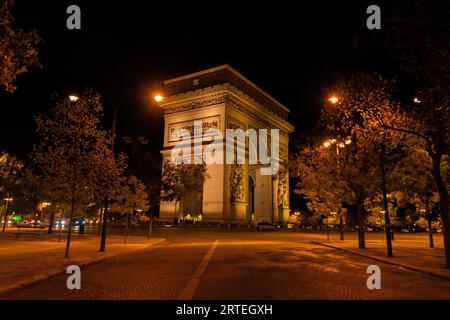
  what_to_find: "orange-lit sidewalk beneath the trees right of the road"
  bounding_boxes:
[313,234,450,281]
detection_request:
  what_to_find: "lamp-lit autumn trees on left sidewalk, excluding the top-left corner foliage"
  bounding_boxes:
[0,90,155,257]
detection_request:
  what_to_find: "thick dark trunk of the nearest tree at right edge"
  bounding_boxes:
[432,154,450,268]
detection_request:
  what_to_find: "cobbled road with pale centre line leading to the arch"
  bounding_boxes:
[1,228,450,299]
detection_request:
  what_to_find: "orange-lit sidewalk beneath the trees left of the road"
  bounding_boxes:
[0,234,165,297]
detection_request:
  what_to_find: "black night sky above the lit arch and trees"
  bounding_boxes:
[0,0,392,156]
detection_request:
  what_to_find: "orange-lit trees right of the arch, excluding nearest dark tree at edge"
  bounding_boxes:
[292,74,449,255]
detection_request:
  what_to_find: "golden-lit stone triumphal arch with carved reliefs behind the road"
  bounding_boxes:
[160,65,294,225]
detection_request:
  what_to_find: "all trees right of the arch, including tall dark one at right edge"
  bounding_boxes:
[293,1,450,267]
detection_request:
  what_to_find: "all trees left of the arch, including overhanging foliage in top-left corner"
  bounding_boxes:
[0,0,165,256]
